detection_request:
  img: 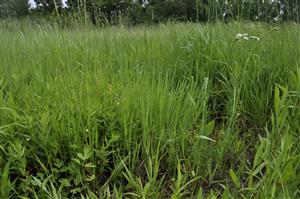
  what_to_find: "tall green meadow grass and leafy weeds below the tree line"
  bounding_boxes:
[0,22,300,199]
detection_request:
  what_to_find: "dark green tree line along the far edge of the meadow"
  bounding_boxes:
[0,0,300,25]
